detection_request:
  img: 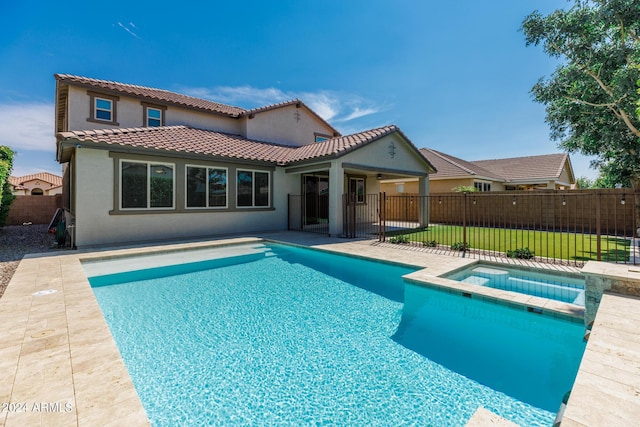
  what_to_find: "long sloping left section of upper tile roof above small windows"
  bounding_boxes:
[54,74,246,117]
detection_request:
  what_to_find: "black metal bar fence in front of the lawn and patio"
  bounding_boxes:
[289,189,640,266]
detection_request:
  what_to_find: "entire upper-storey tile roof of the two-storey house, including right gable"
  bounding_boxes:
[54,74,340,136]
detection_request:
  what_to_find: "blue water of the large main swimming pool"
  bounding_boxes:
[88,245,584,426]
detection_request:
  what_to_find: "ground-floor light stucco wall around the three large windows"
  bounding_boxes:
[75,148,300,247]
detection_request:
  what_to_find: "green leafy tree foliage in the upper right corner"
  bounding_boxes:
[522,0,640,188]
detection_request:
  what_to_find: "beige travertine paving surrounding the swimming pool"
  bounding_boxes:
[0,232,640,426]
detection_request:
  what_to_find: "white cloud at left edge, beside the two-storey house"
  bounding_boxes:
[0,103,56,152]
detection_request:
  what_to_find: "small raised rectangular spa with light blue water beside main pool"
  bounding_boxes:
[446,263,585,307]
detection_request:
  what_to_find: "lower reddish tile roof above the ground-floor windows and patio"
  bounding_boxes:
[57,125,431,166]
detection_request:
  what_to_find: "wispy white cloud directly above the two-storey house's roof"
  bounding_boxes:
[179,85,382,122]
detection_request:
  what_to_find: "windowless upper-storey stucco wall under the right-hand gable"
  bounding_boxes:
[245,105,333,145]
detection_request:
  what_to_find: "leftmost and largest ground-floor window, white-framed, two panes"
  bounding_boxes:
[120,160,175,209]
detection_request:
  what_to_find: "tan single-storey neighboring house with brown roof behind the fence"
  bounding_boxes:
[381,148,576,194]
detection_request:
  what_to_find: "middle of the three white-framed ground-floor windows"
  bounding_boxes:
[187,166,227,208]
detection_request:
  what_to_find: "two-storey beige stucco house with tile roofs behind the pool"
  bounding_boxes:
[55,74,435,246]
